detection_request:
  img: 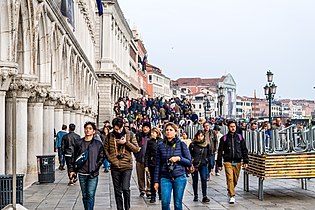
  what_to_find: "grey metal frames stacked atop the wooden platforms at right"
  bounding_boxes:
[243,125,315,155]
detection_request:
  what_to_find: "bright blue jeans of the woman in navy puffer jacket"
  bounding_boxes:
[160,174,187,210]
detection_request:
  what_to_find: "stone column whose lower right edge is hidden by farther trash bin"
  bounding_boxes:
[27,101,43,174]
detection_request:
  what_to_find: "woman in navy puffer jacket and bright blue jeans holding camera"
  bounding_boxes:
[154,122,191,210]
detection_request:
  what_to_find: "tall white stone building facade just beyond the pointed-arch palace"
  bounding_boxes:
[96,0,132,126]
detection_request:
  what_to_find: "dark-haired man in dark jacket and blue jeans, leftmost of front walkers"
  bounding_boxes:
[69,122,104,210]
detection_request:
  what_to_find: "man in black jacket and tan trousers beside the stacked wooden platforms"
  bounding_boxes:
[217,121,248,204]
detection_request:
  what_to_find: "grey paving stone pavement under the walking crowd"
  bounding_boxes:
[24,164,315,210]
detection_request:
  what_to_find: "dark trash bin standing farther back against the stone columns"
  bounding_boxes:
[36,155,55,183]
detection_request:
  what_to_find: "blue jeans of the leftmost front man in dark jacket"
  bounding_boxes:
[79,174,98,210]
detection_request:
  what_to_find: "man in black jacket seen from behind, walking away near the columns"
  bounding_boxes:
[61,123,81,185]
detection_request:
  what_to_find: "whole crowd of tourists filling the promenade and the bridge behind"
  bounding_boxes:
[56,98,306,210]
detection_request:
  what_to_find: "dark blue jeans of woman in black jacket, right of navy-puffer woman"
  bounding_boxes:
[192,165,208,197]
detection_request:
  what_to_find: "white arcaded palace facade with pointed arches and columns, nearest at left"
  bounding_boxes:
[0,0,98,179]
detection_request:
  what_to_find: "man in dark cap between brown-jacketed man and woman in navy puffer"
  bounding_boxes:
[135,122,151,197]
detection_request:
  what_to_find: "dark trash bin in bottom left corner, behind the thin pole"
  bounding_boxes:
[0,174,24,209]
